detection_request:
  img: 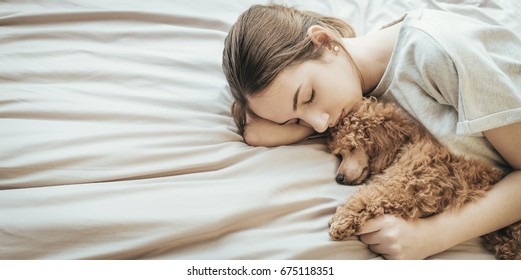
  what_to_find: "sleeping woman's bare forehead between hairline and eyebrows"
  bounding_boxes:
[249,65,307,123]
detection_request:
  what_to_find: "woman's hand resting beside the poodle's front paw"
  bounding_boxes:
[357,215,448,260]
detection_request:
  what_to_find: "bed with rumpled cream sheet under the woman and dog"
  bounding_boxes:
[0,0,521,260]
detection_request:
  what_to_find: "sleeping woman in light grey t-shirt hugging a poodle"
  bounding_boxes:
[223,5,521,259]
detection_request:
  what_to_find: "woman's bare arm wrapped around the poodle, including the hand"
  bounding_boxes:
[360,123,521,259]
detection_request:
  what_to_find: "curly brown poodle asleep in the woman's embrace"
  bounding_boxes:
[328,97,521,259]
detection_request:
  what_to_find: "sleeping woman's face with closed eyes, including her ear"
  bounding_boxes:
[249,49,362,132]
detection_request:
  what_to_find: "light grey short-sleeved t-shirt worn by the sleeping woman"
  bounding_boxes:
[371,10,521,170]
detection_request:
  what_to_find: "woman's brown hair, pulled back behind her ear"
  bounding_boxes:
[222,5,355,136]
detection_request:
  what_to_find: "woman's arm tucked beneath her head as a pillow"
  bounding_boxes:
[244,115,315,147]
